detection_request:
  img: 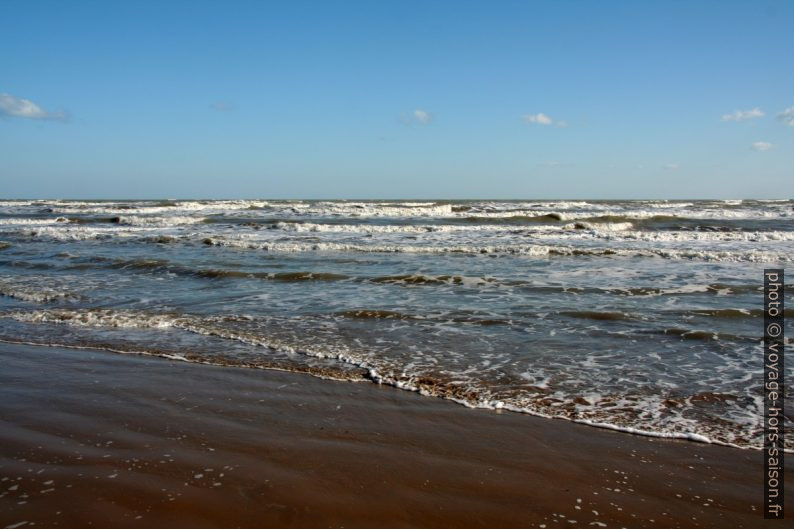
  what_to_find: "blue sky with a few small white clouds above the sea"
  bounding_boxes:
[0,0,794,199]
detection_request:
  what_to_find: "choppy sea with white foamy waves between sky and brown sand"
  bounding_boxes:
[0,200,794,449]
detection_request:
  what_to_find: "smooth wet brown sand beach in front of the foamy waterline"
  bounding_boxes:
[0,344,794,529]
